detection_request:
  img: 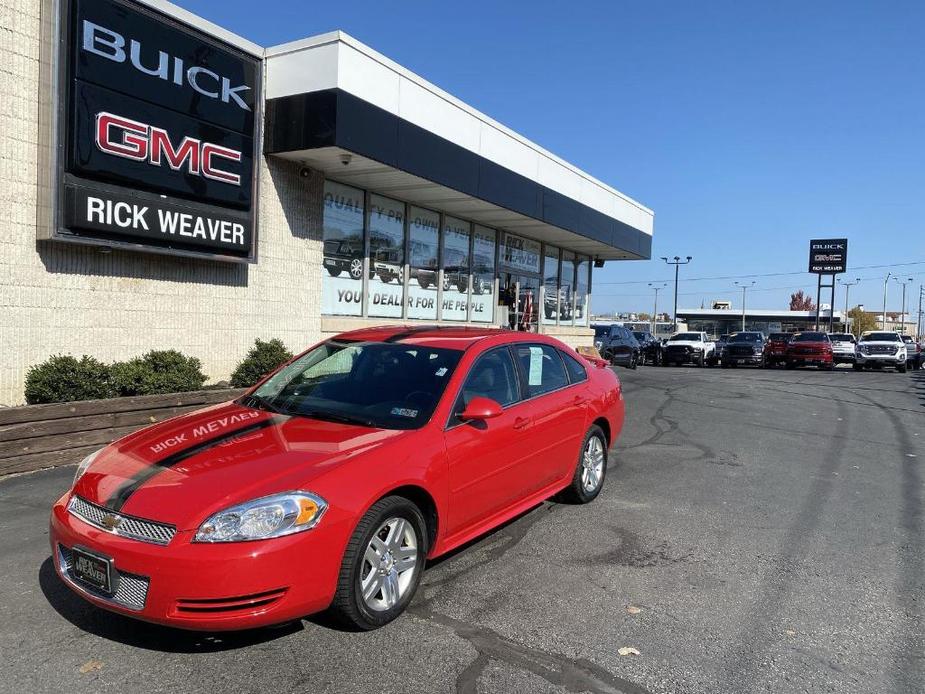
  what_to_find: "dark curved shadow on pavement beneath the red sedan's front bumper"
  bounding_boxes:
[38,557,303,653]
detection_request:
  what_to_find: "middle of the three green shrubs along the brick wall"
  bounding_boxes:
[112,349,206,395]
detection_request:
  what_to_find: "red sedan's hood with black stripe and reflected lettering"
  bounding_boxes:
[75,403,410,530]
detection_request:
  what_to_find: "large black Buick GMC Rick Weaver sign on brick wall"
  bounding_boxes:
[45,0,260,260]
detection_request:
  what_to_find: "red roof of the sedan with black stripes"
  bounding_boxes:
[337,325,547,350]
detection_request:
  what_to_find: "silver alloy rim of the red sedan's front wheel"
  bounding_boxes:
[359,516,418,612]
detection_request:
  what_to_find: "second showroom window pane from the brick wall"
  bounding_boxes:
[366,195,405,318]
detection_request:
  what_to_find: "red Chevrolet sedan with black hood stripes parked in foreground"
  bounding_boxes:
[50,326,624,630]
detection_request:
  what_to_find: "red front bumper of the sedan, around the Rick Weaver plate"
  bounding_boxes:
[49,492,346,631]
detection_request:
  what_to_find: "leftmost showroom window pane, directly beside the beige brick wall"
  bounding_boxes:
[321,181,364,316]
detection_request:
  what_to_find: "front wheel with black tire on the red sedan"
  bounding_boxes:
[331,496,428,631]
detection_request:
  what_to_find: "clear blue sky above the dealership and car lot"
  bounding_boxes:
[178,0,925,312]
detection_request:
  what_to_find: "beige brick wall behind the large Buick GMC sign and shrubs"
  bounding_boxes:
[0,0,322,405]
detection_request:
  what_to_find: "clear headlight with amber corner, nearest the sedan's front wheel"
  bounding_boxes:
[193,492,328,542]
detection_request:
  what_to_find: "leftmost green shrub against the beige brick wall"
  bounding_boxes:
[26,355,115,405]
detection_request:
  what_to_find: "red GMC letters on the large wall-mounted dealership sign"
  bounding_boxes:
[94,111,241,186]
